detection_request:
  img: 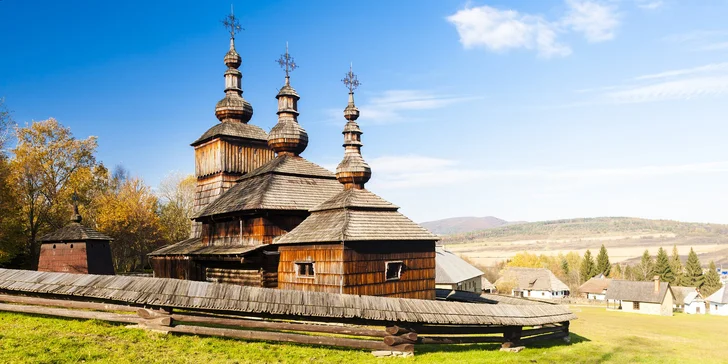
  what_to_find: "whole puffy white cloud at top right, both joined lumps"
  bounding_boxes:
[447,0,619,58]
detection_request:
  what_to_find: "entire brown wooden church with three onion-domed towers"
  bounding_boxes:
[149,15,437,299]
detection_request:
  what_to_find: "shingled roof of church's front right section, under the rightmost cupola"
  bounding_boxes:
[274,189,438,244]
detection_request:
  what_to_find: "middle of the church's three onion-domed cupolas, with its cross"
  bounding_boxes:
[268,43,308,156]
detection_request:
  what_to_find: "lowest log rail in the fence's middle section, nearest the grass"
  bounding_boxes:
[169,325,414,352]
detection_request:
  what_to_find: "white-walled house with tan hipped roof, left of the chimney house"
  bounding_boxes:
[495,268,569,299]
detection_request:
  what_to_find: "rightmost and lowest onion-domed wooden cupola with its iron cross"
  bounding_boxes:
[336,67,372,189]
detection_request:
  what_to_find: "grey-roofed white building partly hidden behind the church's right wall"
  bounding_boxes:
[435,247,492,293]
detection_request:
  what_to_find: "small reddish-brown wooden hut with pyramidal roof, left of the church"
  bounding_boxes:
[38,200,114,275]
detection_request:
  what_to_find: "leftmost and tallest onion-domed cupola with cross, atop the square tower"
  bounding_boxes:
[215,12,253,123]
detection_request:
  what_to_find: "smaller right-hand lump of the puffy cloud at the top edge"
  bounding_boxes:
[563,0,619,43]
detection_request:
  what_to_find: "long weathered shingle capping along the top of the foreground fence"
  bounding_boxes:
[0,269,576,326]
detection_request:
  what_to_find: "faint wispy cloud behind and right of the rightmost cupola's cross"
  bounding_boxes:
[328,90,478,124]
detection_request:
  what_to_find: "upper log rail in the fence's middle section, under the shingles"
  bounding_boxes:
[172,314,387,337]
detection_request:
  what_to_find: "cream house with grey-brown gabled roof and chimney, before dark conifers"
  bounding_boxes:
[606,276,675,316]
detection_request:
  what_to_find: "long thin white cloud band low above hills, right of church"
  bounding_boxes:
[369,155,728,189]
